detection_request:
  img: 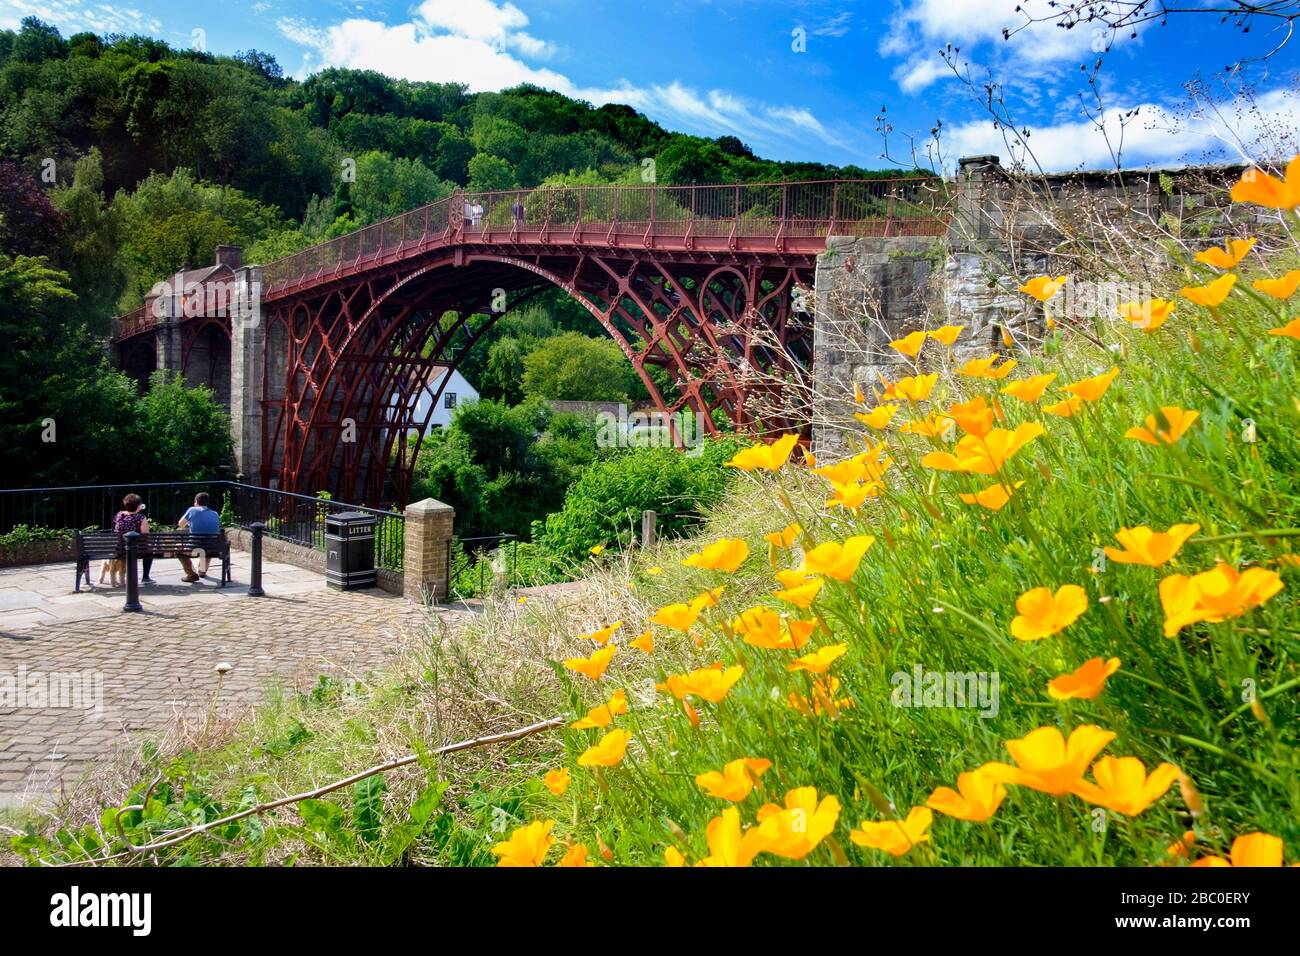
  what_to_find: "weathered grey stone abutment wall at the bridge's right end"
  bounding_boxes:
[811,156,1262,459]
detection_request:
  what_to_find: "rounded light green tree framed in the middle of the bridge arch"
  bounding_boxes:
[524,332,636,402]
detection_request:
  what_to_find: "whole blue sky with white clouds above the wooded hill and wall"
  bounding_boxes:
[0,0,1300,169]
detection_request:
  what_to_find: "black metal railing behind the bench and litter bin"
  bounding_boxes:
[0,481,406,571]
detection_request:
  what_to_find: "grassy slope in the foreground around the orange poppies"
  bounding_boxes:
[16,208,1300,866]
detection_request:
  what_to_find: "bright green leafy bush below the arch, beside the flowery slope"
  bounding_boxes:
[533,440,738,563]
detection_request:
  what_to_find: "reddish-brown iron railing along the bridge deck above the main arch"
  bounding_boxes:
[263,177,948,294]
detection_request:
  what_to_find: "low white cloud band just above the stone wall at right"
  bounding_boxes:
[945,88,1300,170]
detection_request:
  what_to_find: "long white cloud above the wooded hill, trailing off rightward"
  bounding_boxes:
[277,0,852,156]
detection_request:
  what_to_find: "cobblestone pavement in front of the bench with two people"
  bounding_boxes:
[0,553,468,805]
